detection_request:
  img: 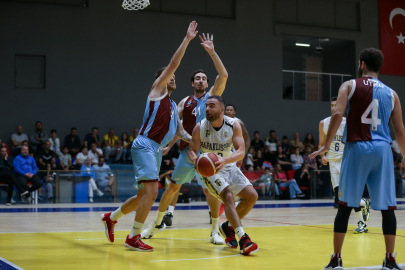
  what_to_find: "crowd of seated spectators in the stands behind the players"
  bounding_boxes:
[0,121,405,204]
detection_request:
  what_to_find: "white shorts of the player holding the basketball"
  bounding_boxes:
[202,164,252,202]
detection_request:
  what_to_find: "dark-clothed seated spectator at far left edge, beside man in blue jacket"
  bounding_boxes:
[0,147,28,206]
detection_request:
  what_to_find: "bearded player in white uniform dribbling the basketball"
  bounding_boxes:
[188,95,259,255]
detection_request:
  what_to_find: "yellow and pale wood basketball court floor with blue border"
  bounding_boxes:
[0,199,405,270]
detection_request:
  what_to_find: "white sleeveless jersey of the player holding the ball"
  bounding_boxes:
[200,115,235,161]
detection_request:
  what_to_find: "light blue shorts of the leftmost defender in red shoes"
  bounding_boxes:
[131,136,163,186]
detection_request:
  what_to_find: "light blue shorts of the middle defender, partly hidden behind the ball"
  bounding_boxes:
[172,146,206,188]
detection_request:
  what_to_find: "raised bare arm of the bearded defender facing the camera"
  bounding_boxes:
[200,34,228,96]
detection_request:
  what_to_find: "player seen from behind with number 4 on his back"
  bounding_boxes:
[310,48,405,270]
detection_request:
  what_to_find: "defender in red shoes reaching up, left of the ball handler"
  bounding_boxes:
[101,21,198,251]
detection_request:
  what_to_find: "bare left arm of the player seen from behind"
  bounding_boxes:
[309,81,353,159]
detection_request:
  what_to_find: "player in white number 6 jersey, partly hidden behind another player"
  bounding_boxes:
[319,97,370,234]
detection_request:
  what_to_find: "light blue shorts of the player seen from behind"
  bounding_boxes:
[339,141,397,210]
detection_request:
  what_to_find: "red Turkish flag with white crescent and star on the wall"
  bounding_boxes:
[379,0,405,76]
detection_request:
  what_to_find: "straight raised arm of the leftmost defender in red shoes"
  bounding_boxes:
[149,21,198,98]
